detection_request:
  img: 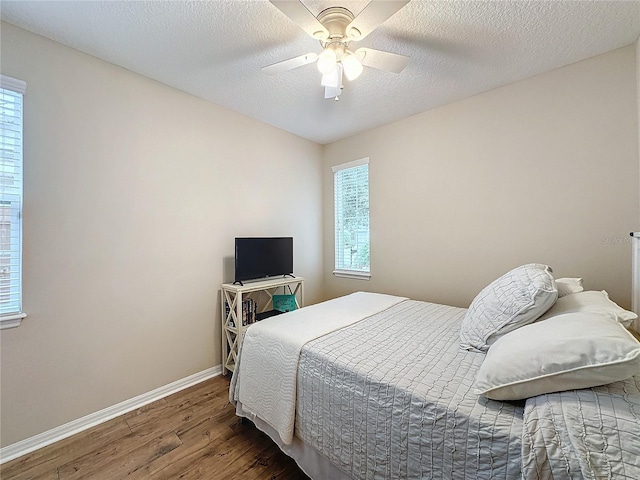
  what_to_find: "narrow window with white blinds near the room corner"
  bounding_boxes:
[333,158,371,279]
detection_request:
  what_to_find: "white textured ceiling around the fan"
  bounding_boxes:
[0,0,640,144]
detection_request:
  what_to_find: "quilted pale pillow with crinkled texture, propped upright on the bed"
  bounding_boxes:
[460,263,558,352]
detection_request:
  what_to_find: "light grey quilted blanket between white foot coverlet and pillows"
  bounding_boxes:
[296,300,523,480]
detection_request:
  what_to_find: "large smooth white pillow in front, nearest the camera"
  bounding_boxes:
[475,313,640,400]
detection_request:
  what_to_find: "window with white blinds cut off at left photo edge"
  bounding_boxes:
[0,75,26,328]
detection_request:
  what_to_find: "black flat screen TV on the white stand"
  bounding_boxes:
[235,237,293,283]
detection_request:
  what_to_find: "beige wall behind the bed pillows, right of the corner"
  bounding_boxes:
[323,45,640,307]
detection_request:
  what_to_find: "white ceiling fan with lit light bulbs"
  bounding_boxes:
[262,0,410,101]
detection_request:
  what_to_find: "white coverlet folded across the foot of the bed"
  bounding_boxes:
[230,292,406,444]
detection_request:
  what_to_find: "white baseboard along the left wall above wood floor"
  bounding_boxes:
[0,365,222,464]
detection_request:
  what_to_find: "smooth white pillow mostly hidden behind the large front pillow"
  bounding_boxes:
[538,290,638,327]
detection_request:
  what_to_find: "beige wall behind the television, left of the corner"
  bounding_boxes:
[0,23,322,446]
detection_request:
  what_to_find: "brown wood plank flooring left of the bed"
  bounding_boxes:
[0,376,307,480]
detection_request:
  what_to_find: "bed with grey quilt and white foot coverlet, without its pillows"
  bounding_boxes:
[230,266,640,480]
